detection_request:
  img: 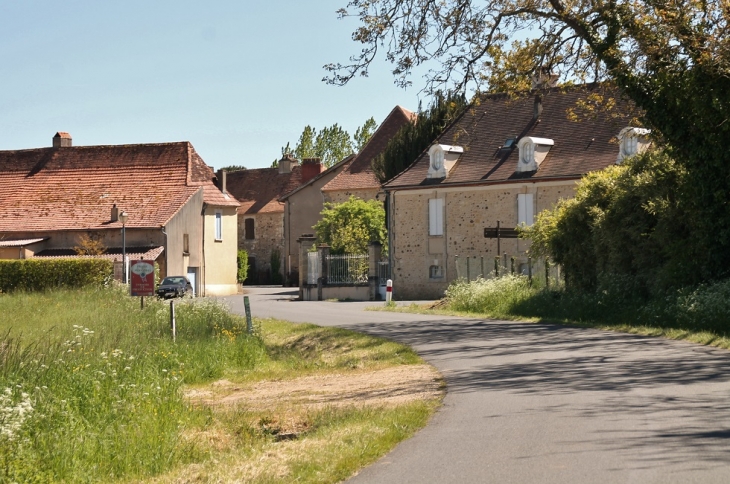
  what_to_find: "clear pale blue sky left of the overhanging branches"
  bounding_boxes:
[0,0,427,168]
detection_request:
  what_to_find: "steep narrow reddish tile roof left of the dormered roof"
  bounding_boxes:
[322,106,416,192]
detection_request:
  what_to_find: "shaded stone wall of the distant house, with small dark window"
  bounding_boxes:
[238,212,284,280]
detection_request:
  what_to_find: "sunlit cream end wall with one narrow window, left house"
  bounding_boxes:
[203,206,238,296]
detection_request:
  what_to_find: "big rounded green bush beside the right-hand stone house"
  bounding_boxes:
[523,151,688,294]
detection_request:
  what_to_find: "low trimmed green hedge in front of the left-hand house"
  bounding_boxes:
[0,259,114,292]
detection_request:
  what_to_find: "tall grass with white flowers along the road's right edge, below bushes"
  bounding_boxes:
[446,276,730,340]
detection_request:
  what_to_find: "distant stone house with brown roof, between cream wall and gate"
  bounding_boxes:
[227,155,330,284]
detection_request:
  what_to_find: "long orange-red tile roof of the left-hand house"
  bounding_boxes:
[0,141,235,233]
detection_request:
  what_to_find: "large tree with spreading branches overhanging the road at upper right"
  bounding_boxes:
[332,0,730,278]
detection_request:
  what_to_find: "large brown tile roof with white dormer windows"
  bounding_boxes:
[385,85,629,188]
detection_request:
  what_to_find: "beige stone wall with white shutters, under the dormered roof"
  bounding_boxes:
[390,180,575,299]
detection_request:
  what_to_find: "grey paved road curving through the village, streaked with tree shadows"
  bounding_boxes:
[220,288,730,484]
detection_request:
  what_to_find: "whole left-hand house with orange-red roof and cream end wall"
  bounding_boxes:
[0,132,238,295]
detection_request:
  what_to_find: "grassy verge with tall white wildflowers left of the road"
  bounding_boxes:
[0,289,440,482]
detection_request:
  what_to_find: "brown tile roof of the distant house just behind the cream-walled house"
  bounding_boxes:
[226,165,302,214]
